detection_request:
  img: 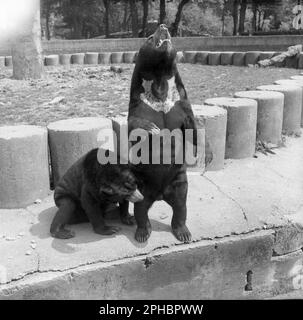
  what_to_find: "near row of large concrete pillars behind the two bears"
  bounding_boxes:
[0,63,303,208]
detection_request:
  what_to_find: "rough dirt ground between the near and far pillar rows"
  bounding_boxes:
[0,64,301,125]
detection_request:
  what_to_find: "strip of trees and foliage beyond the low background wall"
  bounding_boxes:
[41,0,298,39]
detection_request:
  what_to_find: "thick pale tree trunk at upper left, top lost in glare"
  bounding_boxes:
[12,0,43,80]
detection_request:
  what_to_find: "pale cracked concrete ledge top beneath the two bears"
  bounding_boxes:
[0,134,303,288]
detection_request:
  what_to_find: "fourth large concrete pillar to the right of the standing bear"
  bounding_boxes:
[257,84,302,135]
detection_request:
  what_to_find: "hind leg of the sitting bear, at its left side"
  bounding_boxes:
[50,198,77,239]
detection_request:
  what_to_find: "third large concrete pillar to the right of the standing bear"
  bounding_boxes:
[235,90,284,144]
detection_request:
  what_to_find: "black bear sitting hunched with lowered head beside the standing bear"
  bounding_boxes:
[50,149,143,239]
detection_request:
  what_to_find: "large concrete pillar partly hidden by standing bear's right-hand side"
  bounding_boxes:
[192,105,227,171]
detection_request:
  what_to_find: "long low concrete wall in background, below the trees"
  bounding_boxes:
[0,35,303,55]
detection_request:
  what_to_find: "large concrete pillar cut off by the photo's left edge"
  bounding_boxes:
[0,125,50,209]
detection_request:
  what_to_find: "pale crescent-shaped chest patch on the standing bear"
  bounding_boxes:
[140,77,180,113]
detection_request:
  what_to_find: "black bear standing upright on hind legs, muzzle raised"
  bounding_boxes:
[128,24,211,242]
